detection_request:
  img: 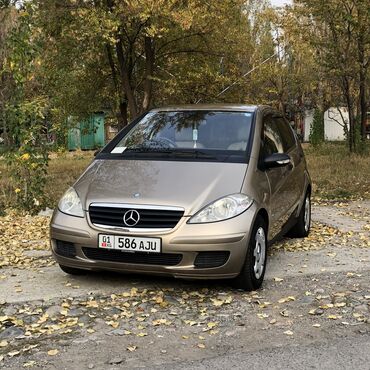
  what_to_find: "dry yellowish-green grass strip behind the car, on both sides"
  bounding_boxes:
[0,143,370,208]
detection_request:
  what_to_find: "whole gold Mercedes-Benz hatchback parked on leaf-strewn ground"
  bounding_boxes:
[50,105,311,290]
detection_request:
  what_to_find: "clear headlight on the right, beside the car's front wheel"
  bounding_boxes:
[188,194,253,224]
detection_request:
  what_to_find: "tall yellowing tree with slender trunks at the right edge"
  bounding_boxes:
[295,0,370,151]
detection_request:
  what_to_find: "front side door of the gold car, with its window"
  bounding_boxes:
[260,113,294,238]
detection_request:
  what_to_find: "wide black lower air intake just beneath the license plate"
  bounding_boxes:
[82,247,182,266]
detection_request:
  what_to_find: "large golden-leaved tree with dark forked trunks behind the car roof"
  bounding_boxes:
[34,0,246,126]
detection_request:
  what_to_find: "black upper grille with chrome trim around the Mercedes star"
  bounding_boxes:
[89,205,184,229]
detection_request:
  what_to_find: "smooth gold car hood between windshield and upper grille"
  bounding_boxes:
[74,159,247,215]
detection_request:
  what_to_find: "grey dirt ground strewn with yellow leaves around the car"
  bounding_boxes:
[0,201,370,369]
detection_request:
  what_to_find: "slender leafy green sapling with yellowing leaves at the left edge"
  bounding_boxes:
[1,2,48,212]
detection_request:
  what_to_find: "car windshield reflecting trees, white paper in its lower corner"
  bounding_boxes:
[105,110,253,162]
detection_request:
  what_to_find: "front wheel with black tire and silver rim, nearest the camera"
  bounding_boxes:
[233,216,267,291]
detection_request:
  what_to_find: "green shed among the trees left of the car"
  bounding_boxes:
[68,113,105,150]
